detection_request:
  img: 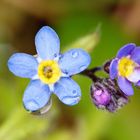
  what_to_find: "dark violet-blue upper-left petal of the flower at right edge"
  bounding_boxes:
[117,43,136,58]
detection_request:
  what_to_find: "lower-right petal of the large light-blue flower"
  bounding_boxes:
[54,78,81,106]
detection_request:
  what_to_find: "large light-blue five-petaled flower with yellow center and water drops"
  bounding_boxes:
[8,26,90,112]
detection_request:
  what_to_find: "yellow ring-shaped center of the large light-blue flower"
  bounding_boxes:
[38,60,61,84]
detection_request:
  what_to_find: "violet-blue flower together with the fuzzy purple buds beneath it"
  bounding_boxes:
[88,43,140,112]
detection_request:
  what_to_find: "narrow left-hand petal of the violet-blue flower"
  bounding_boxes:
[109,59,118,79]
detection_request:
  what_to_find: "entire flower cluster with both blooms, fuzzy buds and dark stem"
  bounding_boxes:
[8,26,140,114]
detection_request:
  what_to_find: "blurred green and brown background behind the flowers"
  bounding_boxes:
[0,0,140,140]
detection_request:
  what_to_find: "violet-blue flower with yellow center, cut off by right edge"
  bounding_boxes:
[110,43,140,96]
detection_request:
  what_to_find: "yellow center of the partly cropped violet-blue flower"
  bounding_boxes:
[118,57,136,77]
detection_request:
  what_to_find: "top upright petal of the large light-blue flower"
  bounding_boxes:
[35,26,60,60]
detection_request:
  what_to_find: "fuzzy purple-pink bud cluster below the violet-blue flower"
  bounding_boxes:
[91,78,128,112]
